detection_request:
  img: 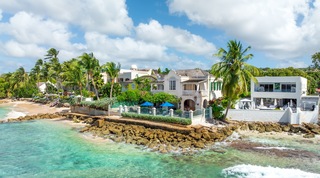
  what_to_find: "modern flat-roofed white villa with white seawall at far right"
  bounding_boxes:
[228,76,319,124]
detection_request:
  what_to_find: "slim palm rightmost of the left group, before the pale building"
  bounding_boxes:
[79,53,100,100]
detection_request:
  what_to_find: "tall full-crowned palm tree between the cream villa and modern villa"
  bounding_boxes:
[211,40,259,120]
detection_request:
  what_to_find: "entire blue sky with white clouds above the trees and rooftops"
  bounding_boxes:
[0,0,320,73]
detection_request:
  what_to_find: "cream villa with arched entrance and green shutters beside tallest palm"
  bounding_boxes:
[151,69,222,111]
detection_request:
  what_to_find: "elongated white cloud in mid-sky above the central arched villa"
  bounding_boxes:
[136,20,216,55]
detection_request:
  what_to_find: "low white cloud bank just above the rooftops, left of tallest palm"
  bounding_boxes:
[85,32,207,68]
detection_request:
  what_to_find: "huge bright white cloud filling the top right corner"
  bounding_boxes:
[168,0,320,60]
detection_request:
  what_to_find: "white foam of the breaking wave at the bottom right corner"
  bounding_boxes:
[222,164,320,178]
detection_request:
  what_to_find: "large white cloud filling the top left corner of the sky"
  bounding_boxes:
[0,0,133,35]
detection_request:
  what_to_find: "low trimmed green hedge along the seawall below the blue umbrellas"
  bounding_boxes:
[121,112,191,125]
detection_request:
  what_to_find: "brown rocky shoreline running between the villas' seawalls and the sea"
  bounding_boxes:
[0,112,320,154]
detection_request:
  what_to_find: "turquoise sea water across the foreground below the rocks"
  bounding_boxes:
[0,108,320,177]
